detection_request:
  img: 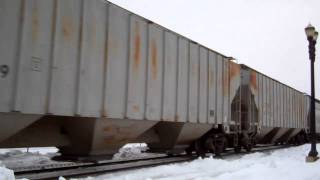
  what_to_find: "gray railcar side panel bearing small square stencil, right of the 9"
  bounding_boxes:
[12,1,55,114]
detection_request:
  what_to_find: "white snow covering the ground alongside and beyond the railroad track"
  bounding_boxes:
[0,144,320,180]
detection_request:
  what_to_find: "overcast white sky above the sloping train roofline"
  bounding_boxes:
[110,0,320,98]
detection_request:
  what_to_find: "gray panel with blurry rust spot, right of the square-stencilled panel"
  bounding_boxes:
[49,0,83,116]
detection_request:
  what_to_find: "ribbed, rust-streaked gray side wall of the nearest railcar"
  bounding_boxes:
[0,0,240,124]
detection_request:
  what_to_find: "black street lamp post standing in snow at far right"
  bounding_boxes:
[305,24,318,162]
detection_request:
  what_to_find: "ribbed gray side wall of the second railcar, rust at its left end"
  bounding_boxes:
[243,66,309,128]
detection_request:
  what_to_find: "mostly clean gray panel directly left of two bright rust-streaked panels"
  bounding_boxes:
[105,5,130,118]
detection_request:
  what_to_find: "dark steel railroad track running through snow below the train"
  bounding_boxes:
[13,145,290,179]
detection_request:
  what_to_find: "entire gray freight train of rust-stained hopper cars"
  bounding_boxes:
[0,0,320,156]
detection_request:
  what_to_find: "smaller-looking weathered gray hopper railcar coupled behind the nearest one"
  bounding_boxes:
[241,65,310,143]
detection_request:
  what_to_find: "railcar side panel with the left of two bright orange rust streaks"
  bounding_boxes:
[127,15,148,119]
